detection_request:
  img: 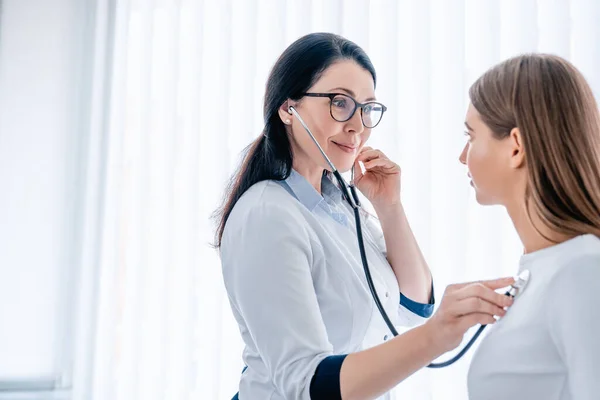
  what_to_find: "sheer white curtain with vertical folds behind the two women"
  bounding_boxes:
[75,0,600,400]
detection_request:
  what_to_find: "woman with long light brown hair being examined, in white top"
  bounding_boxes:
[460,54,600,400]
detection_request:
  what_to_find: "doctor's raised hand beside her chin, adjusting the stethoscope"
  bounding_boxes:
[354,146,400,210]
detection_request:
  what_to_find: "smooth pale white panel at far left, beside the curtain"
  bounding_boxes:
[0,0,91,391]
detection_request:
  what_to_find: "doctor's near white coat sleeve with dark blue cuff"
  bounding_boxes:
[221,204,345,400]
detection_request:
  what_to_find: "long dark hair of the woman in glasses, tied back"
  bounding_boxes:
[215,33,376,248]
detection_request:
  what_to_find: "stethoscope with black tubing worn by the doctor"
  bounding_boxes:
[288,106,530,368]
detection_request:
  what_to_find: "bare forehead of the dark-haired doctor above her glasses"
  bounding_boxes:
[310,60,375,101]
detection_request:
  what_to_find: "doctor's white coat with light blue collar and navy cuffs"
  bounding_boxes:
[221,171,433,400]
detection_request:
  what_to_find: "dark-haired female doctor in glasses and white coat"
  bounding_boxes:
[216,33,513,400]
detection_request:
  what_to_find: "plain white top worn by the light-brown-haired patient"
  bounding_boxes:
[468,235,600,400]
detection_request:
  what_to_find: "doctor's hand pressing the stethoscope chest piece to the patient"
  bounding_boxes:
[425,278,514,354]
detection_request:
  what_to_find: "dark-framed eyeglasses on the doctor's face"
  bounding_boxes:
[303,93,387,128]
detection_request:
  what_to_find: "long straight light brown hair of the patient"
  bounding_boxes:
[469,54,600,236]
